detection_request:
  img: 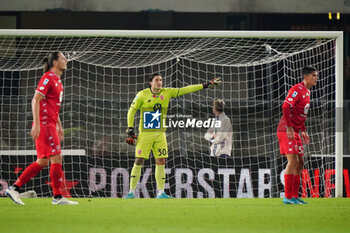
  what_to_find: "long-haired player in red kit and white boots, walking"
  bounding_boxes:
[6,52,78,205]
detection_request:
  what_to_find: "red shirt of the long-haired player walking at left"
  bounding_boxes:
[36,71,63,125]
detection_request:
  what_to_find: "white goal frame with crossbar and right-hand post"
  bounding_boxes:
[0,30,343,197]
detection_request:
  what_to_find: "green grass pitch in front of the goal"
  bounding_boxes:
[0,198,350,233]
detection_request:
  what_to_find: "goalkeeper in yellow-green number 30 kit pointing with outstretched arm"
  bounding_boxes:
[124,73,221,199]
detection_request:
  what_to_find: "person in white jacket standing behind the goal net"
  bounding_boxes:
[204,99,233,158]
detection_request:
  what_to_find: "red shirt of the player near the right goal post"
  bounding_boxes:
[277,82,310,133]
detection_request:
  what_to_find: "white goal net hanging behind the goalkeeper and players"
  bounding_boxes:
[0,31,340,198]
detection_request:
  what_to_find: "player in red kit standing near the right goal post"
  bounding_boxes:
[277,67,318,204]
